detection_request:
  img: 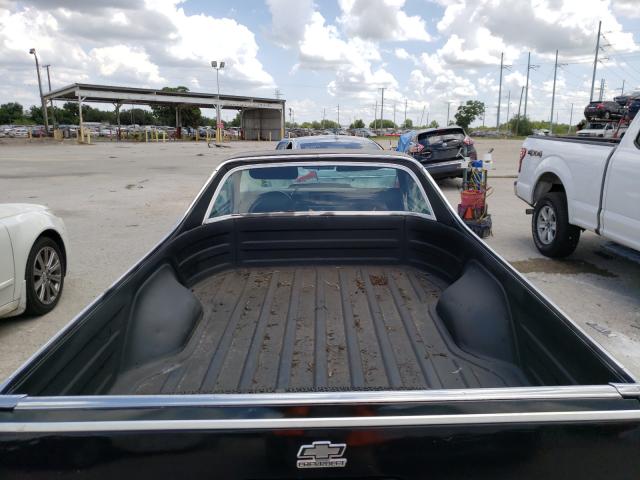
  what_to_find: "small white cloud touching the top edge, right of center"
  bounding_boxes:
[338,0,431,42]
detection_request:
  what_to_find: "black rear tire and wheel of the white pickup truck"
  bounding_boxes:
[531,192,580,258]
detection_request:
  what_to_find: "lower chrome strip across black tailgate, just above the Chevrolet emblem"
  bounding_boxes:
[0,409,640,433]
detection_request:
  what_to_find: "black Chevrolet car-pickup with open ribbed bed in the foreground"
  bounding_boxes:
[0,150,640,480]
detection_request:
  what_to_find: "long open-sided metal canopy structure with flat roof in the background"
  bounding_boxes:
[43,83,285,140]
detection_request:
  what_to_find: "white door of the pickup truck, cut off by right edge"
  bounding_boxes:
[600,129,640,250]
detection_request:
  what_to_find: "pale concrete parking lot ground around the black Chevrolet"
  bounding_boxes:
[0,139,640,378]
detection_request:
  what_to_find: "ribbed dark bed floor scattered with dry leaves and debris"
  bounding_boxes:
[112,266,526,394]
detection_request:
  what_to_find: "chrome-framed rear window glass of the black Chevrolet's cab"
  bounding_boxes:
[208,163,432,218]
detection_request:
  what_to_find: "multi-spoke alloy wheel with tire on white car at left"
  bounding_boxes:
[25,237,64,315]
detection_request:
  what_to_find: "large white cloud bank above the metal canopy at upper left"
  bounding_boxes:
[0,0,275,105]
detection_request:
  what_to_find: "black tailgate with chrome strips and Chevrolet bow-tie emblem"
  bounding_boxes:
[0,386,640,480]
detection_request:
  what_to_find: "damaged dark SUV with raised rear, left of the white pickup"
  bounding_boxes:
[396,126,478,178]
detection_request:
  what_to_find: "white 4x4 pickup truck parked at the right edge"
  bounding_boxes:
[515,115,640,257]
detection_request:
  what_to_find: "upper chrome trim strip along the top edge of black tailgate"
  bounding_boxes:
[16,385,622,410]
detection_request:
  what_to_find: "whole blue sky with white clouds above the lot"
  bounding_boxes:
[0,0,640,125]
